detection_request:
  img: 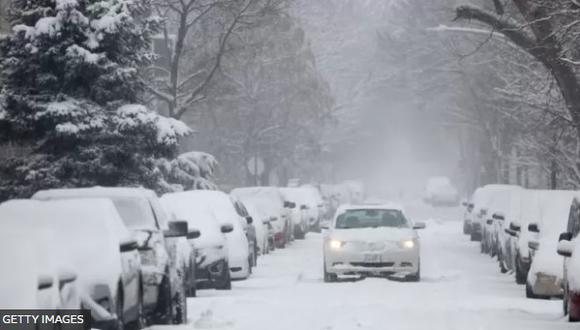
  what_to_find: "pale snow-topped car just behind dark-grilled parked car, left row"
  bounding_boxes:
[180,190,252,279]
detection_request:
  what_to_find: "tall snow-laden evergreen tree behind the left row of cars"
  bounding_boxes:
[0,0,190,198]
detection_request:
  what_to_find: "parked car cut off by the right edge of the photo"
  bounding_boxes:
[558,194,580,322]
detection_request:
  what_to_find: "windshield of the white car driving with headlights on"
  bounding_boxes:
[336,209,409,229]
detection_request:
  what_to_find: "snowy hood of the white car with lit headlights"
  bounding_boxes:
[330,227,417,242]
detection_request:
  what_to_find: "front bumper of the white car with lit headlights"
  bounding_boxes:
[325,247,419,276]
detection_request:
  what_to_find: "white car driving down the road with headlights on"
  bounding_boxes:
[323,204,425,282]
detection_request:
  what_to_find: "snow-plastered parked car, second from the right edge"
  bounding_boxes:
[526,190,575,298]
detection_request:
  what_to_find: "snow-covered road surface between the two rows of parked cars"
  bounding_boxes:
[151,205,576,330]
